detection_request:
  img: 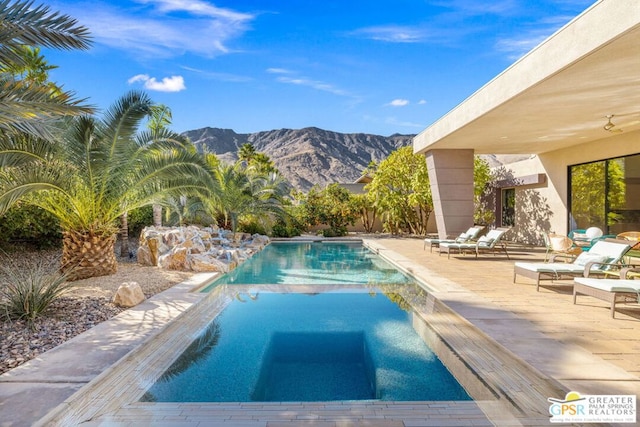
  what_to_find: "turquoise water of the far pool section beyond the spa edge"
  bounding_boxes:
[203,242,411,292]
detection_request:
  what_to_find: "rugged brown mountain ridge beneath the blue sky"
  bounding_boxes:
[184,127,414,191]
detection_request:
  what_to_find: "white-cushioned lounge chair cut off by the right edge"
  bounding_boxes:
[573,274,640,318]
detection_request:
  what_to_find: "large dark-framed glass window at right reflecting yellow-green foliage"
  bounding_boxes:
[569,155,640,235]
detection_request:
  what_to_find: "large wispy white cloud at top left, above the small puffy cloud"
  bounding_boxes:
[65,0,255,58]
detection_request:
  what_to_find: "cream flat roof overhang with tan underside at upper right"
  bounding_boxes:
[413,0,640,154]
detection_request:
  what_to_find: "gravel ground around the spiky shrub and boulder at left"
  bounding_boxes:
[0,242,193,374]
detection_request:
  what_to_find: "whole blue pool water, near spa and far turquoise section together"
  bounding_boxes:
[143,242,470,402]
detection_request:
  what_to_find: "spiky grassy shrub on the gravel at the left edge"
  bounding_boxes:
[0,260,75,323]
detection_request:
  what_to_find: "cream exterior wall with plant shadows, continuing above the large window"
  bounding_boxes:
[494,132,640,244]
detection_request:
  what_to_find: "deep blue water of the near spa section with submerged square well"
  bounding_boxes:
[142,285,470,402]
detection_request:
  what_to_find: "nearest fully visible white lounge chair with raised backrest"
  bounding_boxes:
[513,239,630,291]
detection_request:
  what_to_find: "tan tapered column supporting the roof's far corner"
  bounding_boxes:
[425,150,473,239]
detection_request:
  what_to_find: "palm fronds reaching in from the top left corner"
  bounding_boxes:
[0,0,92,138]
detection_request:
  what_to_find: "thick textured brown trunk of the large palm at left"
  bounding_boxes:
[62,231,118,280]
